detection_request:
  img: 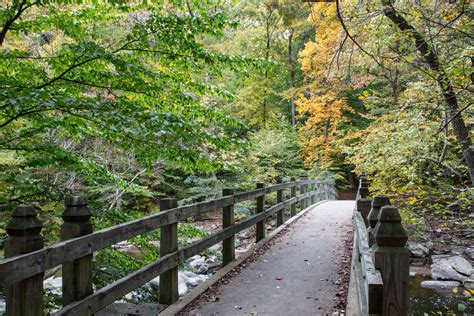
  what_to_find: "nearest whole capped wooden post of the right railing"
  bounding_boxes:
[374,206,409,316]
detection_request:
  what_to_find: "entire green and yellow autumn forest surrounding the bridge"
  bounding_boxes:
[0,0,474,315]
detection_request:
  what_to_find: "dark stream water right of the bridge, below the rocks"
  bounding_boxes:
[408,275,474,316]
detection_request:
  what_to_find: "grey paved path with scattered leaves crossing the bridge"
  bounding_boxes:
[193,201,354,316]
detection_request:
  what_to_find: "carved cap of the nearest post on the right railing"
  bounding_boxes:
[374,206,408,247]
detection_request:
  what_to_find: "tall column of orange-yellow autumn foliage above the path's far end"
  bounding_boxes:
[295,3,352,168]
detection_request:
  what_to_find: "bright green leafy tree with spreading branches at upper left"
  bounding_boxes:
[0,0,255,201]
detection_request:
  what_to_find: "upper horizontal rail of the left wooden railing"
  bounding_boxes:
[0,180,318,285]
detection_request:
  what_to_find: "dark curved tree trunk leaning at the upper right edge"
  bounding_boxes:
[382,0,474,185]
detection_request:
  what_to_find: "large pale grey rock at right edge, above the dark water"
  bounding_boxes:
[431,255,474,282]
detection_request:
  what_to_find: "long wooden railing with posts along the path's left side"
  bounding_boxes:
[0,175,337,315]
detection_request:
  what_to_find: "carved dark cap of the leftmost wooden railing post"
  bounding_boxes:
[5,205,43,236]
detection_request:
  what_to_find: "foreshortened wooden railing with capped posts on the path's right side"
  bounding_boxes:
[348,176,409,316]
